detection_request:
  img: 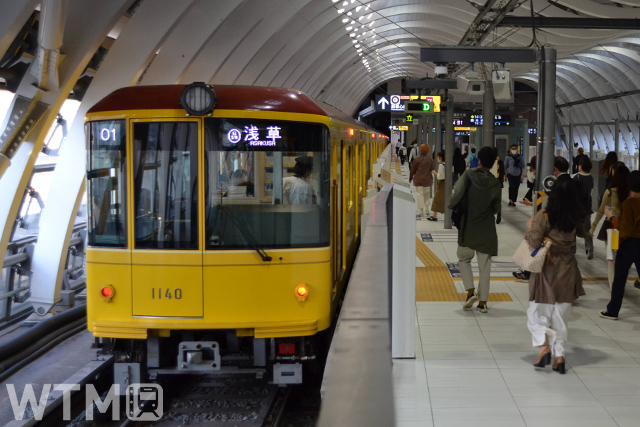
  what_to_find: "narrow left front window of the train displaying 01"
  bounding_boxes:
[86,120,127,248]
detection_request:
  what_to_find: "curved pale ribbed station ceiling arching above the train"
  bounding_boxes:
[0,0,640,143]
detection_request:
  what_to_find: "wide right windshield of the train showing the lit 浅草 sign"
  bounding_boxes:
[205,118,330,250]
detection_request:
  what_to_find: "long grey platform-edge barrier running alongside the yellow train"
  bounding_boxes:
[318,185,395,427]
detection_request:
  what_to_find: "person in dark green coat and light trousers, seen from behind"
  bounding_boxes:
[449,147,502,313]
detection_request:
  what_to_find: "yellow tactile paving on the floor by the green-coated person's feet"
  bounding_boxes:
[416,237,513,301]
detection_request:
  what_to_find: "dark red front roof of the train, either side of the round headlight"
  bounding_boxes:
[88,85,327,116]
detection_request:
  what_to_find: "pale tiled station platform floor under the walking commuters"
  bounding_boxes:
[393,159,640,427]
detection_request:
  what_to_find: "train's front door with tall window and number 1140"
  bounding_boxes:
[131,121,203,317]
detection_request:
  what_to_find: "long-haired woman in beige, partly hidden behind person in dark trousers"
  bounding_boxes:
[590,162,629,288]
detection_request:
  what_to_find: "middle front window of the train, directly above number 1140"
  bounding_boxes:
[133,122,198,249]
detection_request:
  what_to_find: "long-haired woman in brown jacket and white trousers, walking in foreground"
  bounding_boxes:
[524,181,587,374]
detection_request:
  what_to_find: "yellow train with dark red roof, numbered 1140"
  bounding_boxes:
[85,83,388,384]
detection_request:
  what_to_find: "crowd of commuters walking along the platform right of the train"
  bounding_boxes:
[409,143,640,374]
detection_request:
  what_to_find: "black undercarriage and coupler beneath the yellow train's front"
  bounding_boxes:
[97,330,329,390]
